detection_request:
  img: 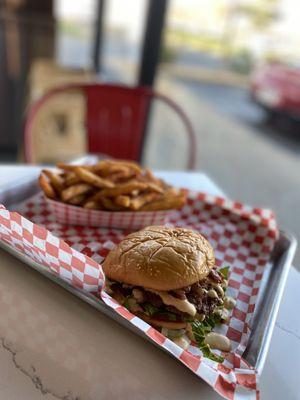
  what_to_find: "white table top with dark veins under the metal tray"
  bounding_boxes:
[0,166,300,400]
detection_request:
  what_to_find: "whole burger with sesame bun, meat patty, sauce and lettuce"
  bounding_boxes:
[103,226,234,361]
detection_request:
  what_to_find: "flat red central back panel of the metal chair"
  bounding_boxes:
[85,85,150,160]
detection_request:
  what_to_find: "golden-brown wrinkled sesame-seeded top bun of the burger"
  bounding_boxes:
[103,226,215,291]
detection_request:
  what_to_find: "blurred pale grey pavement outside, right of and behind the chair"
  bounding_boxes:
[145,77,300,267]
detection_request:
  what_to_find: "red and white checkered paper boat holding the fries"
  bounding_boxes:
[46,198,173,230]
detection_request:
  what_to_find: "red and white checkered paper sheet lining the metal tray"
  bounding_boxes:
[0,192,278,400]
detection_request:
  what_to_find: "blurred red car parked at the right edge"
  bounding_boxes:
[250,64,300,118]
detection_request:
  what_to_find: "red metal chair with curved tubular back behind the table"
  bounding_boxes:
[24,83,196,169]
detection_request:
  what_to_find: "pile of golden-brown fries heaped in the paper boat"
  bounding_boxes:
[39,160,186,211]
